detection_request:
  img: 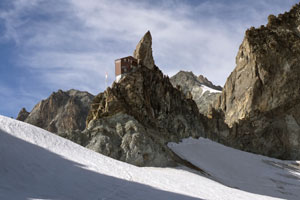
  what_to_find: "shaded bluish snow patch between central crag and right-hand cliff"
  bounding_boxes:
[168,138,300,200]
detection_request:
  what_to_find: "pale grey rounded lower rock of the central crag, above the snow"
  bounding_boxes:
[86,113,175,166]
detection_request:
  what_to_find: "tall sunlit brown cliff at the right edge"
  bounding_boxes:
[215,4,300,159]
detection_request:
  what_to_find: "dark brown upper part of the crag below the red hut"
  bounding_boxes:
[87,66,204,128]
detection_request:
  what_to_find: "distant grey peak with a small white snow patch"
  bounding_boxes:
[170,71,222,115]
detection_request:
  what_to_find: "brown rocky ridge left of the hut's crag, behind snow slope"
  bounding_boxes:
[18,90,94,144]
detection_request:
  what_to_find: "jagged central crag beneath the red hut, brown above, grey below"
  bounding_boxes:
[85,33,205,166]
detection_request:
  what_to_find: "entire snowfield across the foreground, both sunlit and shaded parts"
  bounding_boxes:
[0,116,300,200]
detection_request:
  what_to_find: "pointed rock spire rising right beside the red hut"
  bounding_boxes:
[133,31,155,69]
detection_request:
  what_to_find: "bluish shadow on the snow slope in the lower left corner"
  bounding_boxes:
[0,130,204,200]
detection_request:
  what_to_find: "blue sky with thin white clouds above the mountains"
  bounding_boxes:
[0,0,299,117]
